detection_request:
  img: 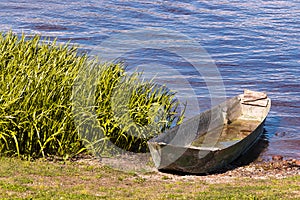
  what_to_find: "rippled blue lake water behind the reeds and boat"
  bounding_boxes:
[0,0,300,159]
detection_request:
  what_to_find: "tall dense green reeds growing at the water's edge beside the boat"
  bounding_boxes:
[0,32,183,158]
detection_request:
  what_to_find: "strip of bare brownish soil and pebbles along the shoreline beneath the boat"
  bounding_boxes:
[75,153,300,183]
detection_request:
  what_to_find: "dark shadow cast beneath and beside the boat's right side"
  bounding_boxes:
[159,129,269,176]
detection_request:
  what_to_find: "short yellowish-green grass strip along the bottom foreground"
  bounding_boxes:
[0,157,300,200]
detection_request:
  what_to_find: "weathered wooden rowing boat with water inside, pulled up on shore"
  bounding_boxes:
[148,90,271,174]
